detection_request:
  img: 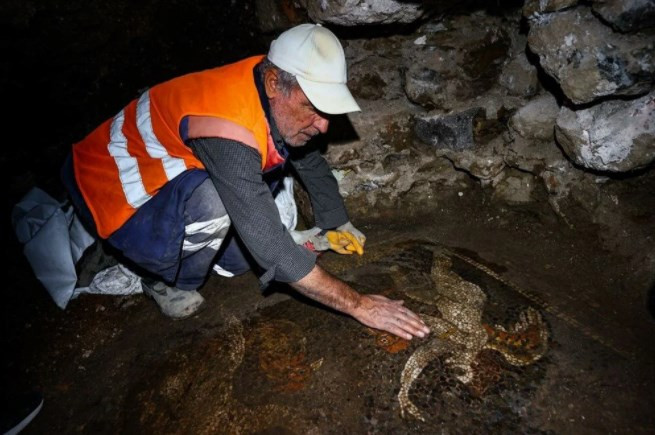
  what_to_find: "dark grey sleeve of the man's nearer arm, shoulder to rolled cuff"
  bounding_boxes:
[187,137,316,286]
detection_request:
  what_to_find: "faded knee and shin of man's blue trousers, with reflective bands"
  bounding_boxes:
[176,179,231,290]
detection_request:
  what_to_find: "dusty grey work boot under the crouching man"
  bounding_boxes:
[141,279,205,320]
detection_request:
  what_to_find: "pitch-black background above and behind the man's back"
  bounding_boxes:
[0,0,268,209]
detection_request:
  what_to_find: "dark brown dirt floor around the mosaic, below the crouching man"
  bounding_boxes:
[3,182,655,433]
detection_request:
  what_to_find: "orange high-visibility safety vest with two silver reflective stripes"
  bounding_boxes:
[73,56,280,238]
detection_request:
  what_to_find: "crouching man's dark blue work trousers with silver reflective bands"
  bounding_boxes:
[62,157,297,290]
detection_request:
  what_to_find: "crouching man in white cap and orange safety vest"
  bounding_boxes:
[64,24,429,339]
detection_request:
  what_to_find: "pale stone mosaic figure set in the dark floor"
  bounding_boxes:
[398,253,548,421]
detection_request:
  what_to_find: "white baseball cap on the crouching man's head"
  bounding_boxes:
[268,24,361,115]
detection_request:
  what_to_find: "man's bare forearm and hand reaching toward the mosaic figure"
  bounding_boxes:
[291,265,430,340]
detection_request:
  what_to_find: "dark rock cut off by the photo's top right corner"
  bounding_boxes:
[592,0,655,32]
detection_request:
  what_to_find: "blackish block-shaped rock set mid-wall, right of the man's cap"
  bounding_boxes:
[414,107,481,151]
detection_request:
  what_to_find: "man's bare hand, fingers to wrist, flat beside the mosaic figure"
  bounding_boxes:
[352,295,430,340]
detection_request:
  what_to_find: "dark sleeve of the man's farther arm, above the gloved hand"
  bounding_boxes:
[291,149,349,229]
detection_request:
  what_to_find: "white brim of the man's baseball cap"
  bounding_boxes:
[296,76,362,115]
